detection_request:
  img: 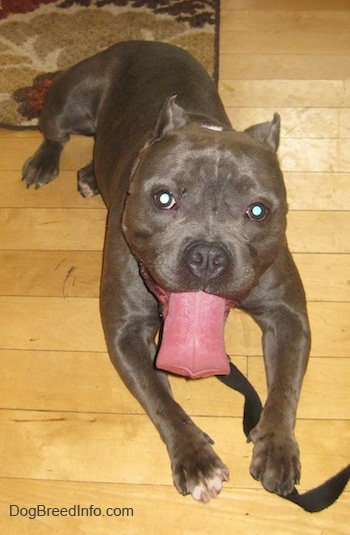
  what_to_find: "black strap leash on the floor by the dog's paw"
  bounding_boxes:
[216,362,350,513]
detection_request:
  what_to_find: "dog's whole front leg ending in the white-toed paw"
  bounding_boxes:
[101,227,228,502]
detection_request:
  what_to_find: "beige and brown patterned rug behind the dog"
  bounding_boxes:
[0,0,219,129]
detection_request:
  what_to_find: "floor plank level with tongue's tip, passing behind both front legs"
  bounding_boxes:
[0,350,350,420]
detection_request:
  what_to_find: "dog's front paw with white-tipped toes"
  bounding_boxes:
[171,435,229,502]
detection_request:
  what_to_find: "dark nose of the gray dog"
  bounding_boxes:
[186,242,230,281]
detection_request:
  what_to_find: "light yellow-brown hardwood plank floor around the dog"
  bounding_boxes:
[0,0,350,535]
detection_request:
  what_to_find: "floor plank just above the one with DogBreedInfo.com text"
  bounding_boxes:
[0,410,350,490]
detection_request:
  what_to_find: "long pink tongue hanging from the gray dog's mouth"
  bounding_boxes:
[156,292,230,379]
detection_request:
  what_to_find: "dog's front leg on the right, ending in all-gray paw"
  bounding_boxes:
[243,253,310,495]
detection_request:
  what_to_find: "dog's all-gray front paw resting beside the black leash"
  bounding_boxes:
[250,426,300,496]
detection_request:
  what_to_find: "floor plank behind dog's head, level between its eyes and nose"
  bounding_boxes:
[0,207,350,253]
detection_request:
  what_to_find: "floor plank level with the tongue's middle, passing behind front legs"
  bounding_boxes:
[0,297,350,357]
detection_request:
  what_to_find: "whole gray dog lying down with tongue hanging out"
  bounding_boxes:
[23,41,310,501]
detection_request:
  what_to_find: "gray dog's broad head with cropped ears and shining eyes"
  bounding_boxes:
[123,97,287,302]
